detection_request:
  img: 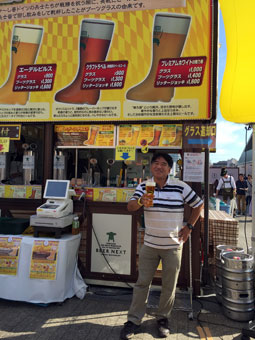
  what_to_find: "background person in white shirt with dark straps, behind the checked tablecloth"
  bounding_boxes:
[215,168,236,204]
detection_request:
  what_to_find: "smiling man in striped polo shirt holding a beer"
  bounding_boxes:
[120,153,203,340]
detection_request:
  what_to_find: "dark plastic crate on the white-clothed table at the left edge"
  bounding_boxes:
[0,217,29,235]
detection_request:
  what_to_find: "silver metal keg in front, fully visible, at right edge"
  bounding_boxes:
[221,252,254,322]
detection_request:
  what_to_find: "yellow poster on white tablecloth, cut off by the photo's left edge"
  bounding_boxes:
[0,236,22,275]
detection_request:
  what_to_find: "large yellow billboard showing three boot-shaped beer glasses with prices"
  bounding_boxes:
[0,0,217,122]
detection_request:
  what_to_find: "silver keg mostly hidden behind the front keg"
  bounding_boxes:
[215,244,244,304]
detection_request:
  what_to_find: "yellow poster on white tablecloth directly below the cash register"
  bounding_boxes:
[29,240,59,280]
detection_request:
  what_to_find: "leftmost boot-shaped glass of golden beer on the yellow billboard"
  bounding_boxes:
[0,25,43,105]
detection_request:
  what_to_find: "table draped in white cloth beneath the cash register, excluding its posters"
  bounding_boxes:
[0,234,87,303]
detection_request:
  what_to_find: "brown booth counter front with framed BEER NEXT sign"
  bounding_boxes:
[79,200,200,294]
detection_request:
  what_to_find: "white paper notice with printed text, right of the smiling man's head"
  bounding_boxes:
[183,152,205,183]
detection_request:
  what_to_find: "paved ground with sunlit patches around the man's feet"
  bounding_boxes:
[0,217,253,340]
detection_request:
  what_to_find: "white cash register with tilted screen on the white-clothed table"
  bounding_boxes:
[30,179,75,237]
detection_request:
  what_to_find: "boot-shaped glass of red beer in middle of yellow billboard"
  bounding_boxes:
[55,19,114,105]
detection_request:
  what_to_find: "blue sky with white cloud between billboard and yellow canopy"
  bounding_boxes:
[210,12,252,163]
